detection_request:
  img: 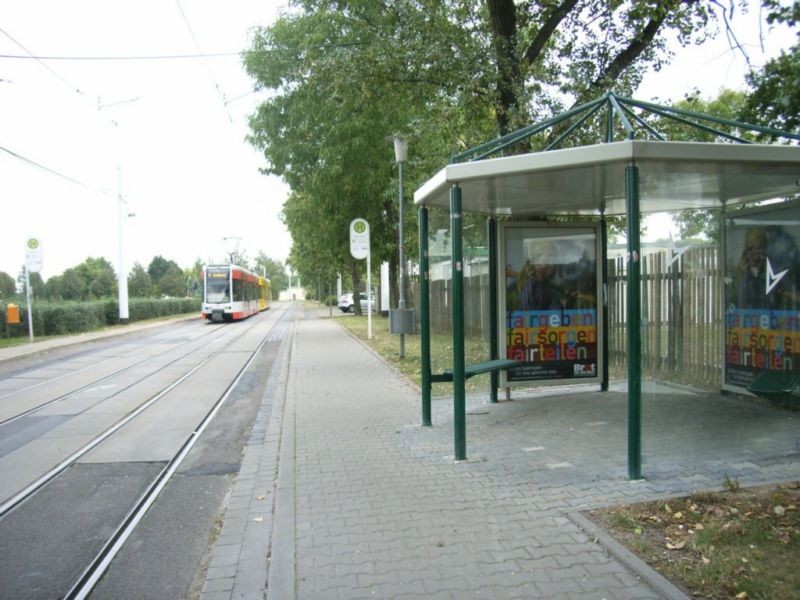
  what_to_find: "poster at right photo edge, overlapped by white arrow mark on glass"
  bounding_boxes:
[725,204,800,388]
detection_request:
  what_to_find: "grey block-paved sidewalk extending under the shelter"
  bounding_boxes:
[203,311,800,600]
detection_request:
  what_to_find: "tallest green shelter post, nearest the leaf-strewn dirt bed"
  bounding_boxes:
[625,165,642,479]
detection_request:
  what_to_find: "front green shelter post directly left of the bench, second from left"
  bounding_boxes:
[450,185,467,460]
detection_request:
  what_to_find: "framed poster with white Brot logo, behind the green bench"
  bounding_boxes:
[501,223,600,383]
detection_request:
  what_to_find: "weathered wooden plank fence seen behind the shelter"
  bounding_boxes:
[408,246,724,389]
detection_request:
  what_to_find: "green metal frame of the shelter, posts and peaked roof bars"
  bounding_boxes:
[419,92,800,479]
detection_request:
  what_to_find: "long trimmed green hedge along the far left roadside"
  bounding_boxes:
[0,298,200,337]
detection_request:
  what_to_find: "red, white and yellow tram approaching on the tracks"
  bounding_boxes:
[201,264,270,322]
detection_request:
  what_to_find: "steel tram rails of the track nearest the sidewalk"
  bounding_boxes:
[0,308,289,598]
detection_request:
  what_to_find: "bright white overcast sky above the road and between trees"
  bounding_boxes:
[0,0,793,279]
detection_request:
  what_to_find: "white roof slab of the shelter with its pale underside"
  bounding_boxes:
[414,140,800,215]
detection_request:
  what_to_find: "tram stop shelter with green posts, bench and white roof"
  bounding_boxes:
[414,93,800,479]
